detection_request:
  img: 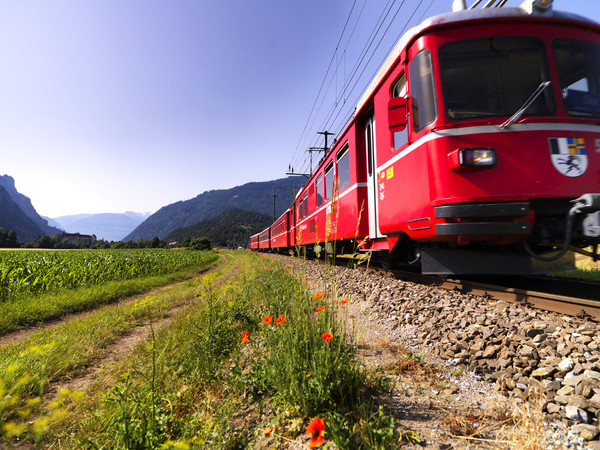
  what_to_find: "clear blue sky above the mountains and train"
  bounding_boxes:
[0,0,600,217]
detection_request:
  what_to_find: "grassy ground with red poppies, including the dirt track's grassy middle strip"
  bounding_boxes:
[0,252,401,449]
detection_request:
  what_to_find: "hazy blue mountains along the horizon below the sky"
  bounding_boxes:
[0,175,305,245]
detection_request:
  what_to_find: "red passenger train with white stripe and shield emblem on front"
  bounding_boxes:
[251,0,600,274]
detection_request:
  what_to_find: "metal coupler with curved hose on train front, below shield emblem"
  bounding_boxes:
[523,193,600,261]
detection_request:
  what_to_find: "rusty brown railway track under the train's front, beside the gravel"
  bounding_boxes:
[356,267,600,322]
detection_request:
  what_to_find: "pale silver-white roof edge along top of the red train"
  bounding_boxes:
[356,1,598,111]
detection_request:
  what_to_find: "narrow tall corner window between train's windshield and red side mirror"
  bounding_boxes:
[409,50,437,131]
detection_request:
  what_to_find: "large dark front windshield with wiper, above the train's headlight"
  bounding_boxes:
[439,37,554,120]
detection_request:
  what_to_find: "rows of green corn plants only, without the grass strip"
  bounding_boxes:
[0,249,216,301]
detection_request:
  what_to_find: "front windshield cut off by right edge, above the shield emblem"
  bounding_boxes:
[552,39,600,117]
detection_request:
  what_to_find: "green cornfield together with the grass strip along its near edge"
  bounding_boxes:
[0,249,219,336]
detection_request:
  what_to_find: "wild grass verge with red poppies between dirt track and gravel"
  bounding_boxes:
[10,252,400,449]
